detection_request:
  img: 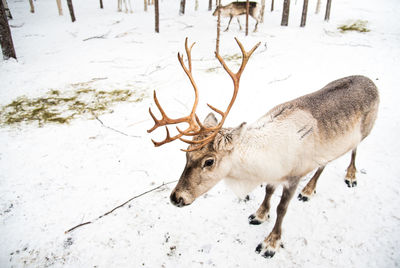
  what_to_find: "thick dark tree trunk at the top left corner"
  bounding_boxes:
[0,1,17,60]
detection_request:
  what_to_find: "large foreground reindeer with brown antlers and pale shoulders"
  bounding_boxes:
[148,39,379,258]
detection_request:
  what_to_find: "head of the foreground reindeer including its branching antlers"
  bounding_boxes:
[148,38,260,207]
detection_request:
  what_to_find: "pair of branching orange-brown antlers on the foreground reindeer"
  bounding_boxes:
[147,38,260,152]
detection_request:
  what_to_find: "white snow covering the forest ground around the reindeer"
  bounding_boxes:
[0,0,400,267]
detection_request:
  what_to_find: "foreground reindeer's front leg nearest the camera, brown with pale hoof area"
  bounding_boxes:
[256,177,300,258]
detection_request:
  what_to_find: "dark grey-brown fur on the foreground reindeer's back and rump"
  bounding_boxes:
[270,76,379,138]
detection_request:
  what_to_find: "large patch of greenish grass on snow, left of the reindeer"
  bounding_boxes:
[0,85,145,127]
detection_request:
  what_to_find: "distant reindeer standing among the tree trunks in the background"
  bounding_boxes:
[213,2,261,32]
